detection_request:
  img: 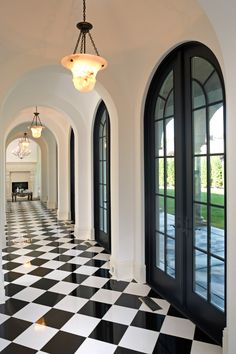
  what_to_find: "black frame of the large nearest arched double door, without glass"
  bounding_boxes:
[144,42,227,343]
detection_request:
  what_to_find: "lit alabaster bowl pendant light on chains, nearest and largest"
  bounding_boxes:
[61,0,107,92]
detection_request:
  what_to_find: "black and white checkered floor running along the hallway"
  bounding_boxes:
[0,201,222,354]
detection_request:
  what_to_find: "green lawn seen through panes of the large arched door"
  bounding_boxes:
[159,188,224,229]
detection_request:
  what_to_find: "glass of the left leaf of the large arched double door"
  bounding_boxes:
[155,70,176,278]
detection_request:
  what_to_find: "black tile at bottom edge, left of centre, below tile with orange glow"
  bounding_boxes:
[41,331,85,354]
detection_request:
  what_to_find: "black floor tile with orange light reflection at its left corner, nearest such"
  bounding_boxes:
[37,309,73,329]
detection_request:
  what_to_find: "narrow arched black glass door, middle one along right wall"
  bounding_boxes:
[93,101,111,252]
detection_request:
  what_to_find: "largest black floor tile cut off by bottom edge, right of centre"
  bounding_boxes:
[153,333,192,354]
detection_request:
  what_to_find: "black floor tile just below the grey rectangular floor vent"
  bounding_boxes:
[131,311,165,332]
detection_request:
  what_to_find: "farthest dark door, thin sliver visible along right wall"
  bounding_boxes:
[70,128,75,223]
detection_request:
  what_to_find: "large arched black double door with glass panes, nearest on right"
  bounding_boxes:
[145,42,226,343]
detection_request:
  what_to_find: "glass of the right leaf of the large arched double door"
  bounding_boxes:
[191,57,225,311]
